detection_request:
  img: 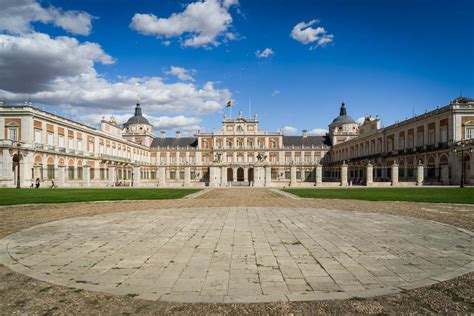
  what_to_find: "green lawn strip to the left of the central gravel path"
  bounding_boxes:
[0,188,200,205]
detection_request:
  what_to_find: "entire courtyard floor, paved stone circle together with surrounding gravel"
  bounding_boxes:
[0,188,474,313]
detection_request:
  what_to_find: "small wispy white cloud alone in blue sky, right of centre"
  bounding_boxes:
[290,19,334,49]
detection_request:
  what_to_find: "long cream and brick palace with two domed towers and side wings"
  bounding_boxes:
[0,97,474,187]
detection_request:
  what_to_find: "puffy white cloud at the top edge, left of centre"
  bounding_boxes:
[130,0,238,47]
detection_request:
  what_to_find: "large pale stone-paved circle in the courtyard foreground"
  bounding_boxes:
[0,207,474,302]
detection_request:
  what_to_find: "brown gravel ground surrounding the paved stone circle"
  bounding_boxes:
[0,189,474,315]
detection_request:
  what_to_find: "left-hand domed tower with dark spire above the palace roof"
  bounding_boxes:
[123,100,153,146]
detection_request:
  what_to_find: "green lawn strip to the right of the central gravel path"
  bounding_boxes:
[284,188,474,204]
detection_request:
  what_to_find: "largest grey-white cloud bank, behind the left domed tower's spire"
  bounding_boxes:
[0,33,231,114]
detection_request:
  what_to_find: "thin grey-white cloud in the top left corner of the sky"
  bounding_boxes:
[0,0,93,35]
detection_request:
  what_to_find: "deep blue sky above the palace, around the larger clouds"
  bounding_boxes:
[0,0,474,133]
